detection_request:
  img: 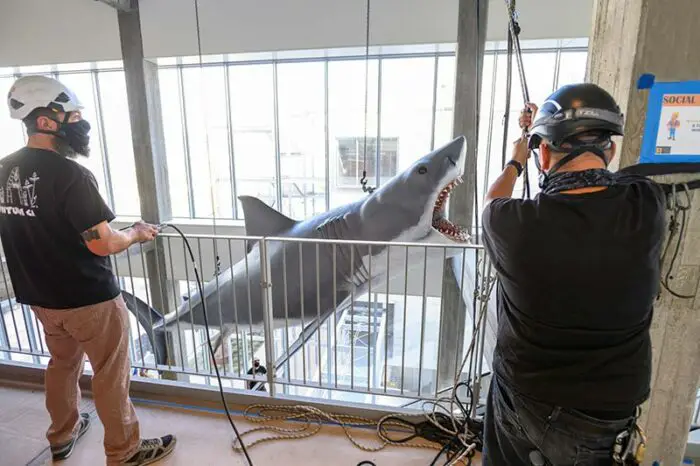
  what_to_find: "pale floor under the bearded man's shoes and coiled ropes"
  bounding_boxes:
[0,385,482,466]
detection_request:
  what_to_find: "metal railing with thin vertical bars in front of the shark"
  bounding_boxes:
[0,233,490,405]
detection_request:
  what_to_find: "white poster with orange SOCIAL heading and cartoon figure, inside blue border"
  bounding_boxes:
[656,94,700,155]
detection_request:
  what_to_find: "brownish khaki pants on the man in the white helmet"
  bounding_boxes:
[32,296,140,464]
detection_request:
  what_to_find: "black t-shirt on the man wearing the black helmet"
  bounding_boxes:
[483,178,665,412]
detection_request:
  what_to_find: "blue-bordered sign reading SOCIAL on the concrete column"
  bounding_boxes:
[639,80,700,163]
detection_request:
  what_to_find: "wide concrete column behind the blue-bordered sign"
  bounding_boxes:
[587,0,700,465]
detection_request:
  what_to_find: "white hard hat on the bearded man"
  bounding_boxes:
[7,76,83,120]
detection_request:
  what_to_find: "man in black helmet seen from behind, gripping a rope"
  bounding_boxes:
[483,84,665,466]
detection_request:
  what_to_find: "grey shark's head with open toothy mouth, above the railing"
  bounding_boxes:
[362,136,469,244]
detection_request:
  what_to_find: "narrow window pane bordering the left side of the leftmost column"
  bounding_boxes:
[96,71,141,217]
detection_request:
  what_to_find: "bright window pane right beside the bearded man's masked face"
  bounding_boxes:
[58,73,114,207]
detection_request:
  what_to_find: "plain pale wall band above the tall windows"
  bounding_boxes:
[0,0,593,67]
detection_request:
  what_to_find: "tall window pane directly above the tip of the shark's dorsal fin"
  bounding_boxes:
[229,65,277,218]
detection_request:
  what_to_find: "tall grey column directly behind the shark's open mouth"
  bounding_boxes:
[437,0,488,390]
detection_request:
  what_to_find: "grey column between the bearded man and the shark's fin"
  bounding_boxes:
[117,0,174,364]
